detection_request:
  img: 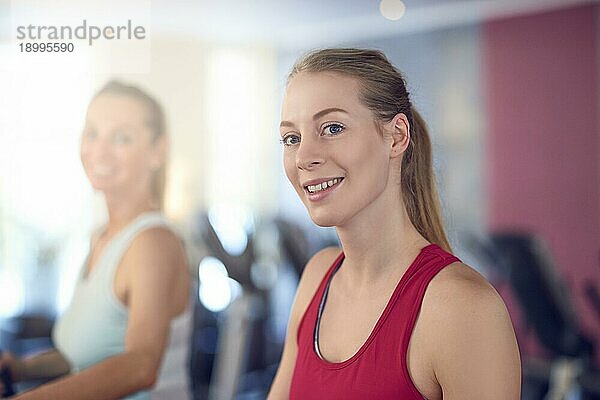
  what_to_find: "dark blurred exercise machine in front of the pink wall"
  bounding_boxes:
[469,232,600,400]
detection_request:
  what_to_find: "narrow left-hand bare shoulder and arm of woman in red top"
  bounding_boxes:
[268,247,341,400]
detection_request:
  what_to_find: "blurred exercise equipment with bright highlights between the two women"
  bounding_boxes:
[191,210,328,400]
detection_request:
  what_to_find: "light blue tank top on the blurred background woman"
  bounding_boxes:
[53,212,192,400]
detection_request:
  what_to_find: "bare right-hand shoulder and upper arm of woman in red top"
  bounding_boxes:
[419,262,521,400]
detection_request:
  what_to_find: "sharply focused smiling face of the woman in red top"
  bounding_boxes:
[280,72,398,226]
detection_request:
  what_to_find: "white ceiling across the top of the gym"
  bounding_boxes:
[0,0,600,49]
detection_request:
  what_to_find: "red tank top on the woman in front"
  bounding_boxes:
[290,244,460,400]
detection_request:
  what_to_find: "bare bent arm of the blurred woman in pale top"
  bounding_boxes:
[17,228,188,400]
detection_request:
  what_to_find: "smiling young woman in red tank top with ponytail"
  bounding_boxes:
[269,49,521,400]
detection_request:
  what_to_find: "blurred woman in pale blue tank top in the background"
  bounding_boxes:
[0,81,192,400]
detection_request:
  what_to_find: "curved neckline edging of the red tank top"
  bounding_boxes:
[310,243,439,369]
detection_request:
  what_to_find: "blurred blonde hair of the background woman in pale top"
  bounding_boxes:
[92,80,167,210]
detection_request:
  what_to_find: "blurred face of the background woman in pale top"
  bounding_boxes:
[81,94,163,200]
